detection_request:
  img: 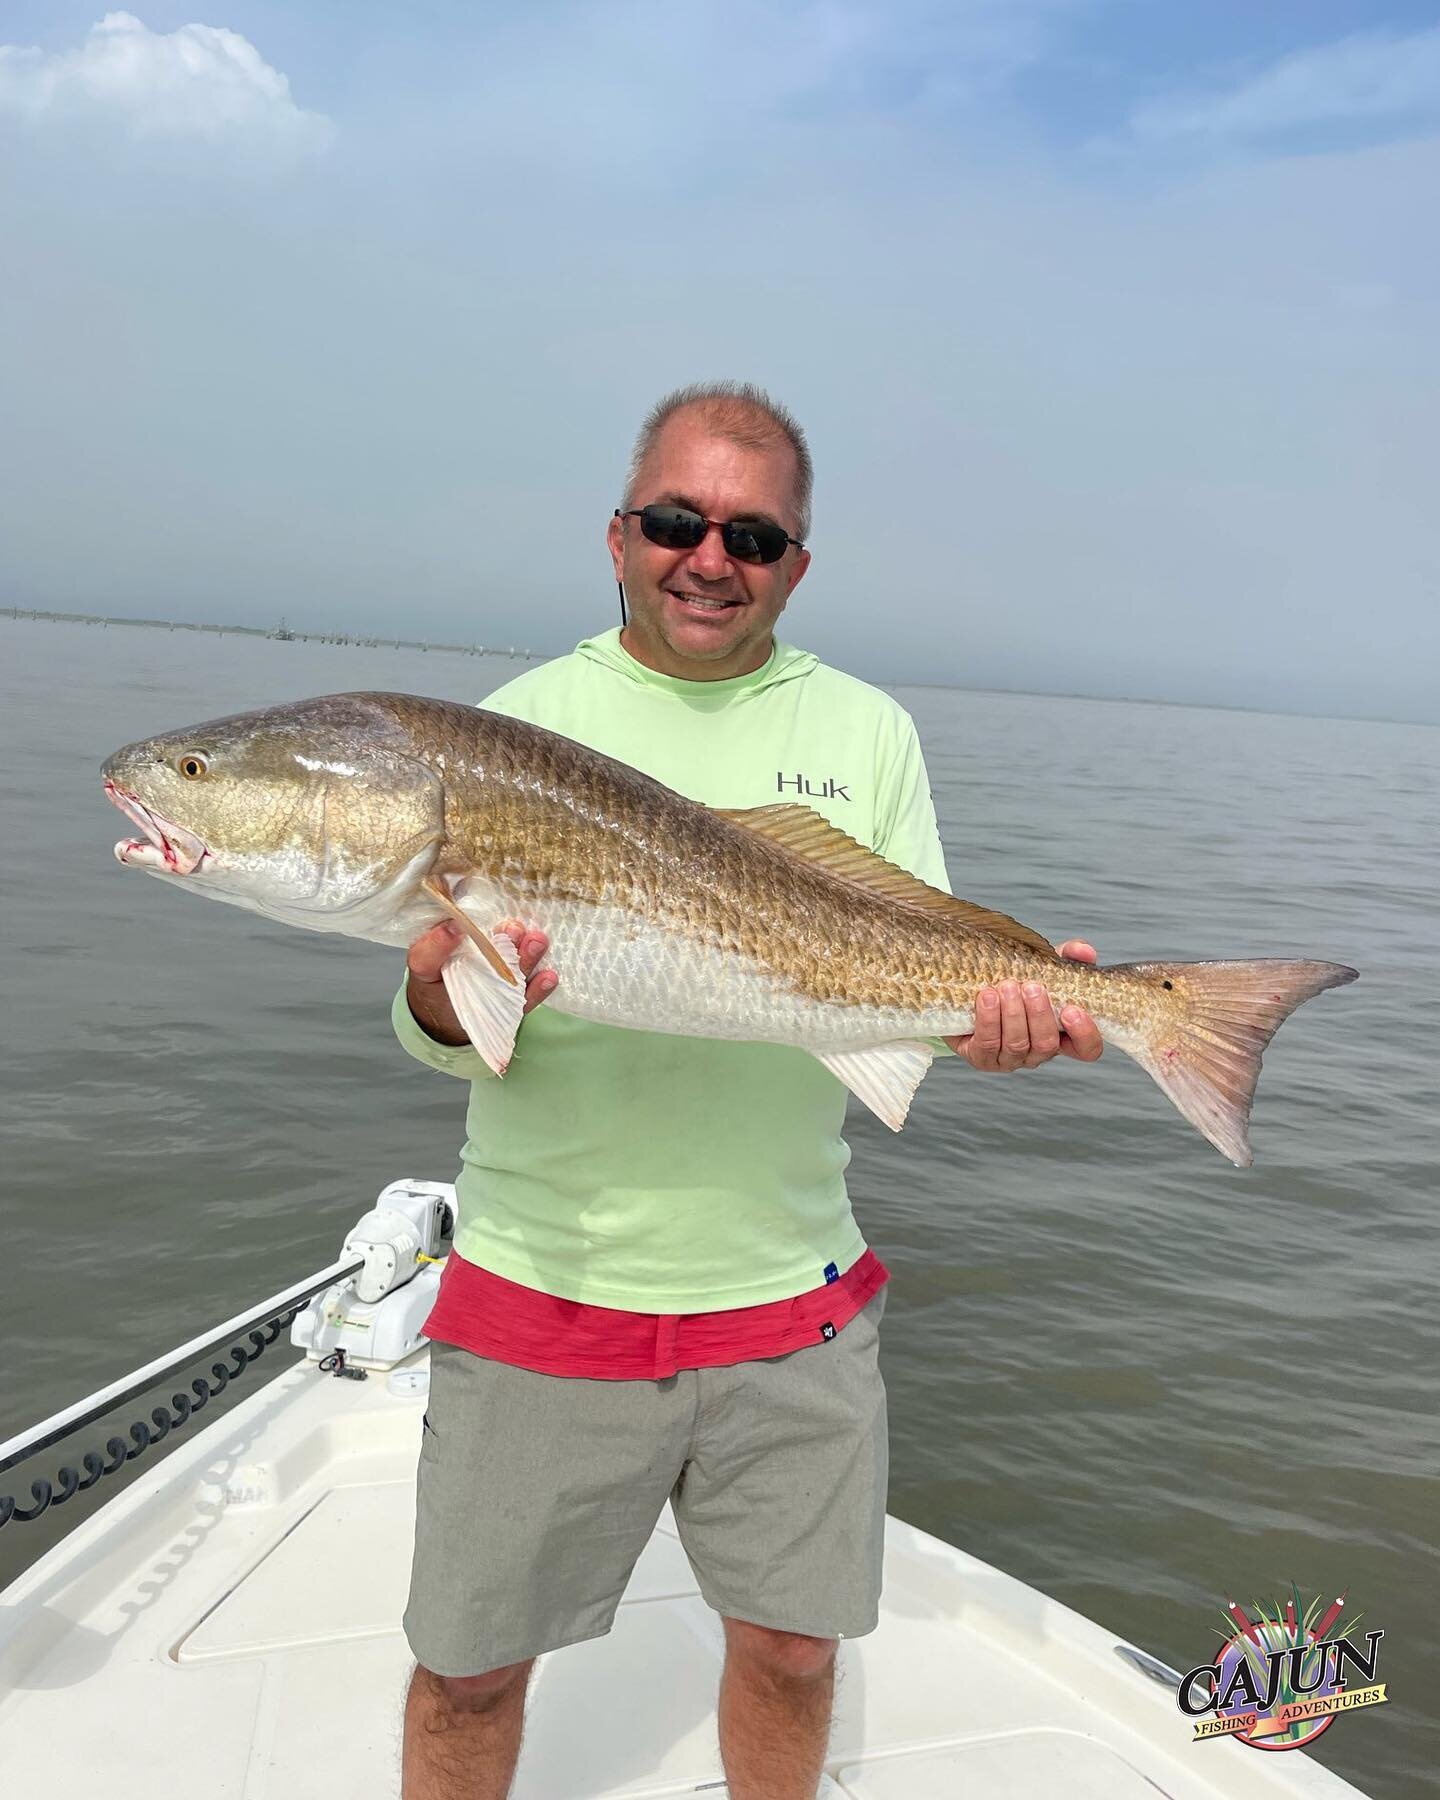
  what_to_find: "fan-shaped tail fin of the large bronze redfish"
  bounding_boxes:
[1107,958,1357,1168]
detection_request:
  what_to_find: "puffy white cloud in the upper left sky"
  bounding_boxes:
[0,13,335,155]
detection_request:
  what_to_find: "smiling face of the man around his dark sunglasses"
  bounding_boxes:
[608,410,810,680]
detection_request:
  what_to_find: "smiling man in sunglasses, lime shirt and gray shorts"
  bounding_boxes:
[394,383,1102,1800]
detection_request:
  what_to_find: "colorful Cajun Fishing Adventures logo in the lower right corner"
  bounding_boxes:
[1175,1584,1388,1750]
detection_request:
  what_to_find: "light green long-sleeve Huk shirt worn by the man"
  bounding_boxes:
[394,630,949,1312]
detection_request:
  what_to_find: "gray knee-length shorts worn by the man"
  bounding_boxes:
[405,1289,889,1676]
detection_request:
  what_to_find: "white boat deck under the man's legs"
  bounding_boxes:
[0,1355,1357,1800]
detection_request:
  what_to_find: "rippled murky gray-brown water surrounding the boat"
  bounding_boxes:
[0,619,1440,1796]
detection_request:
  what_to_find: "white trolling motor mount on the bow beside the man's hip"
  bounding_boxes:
[290,1181,457,1373]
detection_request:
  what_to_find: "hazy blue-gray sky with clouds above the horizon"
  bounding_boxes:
[0,0,1440,722]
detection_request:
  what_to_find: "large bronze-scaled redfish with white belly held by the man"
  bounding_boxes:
[104,693,1355,1166]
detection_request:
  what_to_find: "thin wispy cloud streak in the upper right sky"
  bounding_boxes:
[1130,29,1440,140]
